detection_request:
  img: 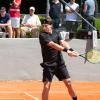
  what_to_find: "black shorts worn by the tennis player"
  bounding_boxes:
[40,64,70,82]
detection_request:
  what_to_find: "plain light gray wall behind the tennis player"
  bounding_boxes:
[0,39,100,81]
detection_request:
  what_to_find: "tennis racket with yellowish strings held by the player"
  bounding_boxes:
[79,49,100,64]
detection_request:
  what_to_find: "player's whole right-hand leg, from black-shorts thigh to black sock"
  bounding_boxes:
[55,64,77,100]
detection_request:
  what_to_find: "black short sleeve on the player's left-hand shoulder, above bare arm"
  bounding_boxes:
[39,33,52,44]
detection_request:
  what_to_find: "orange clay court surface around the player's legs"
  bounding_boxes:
[0,81,100,100]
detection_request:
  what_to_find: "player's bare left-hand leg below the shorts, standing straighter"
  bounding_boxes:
[42,82,51,100]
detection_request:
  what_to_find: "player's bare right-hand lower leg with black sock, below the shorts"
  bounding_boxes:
[63,78,77,100]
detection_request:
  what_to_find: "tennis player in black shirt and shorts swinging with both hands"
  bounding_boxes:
[39,19,78,100]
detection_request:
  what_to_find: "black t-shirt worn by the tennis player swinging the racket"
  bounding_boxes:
[39,32,64,64]
